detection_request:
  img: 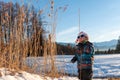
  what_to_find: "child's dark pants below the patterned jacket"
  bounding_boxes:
[78,69,93,80]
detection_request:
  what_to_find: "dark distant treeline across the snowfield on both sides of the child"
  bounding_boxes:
[57,37,120,55]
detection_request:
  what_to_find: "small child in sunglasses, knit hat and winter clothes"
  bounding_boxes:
[71,32,94,80]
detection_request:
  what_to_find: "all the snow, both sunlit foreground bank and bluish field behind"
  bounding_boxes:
[0,54,120,80]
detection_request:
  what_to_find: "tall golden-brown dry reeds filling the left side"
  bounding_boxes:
[0,0,58,76]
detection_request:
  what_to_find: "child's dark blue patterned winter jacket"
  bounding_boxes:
[71,42,94,69]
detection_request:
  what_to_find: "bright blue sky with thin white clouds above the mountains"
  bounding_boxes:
[5,0,120,43]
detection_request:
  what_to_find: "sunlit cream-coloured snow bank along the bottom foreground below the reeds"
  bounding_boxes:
[0,68,107,80]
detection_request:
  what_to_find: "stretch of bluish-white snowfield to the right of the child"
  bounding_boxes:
[93,54,120,77]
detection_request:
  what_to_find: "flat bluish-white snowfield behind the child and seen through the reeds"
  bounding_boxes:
[27,54,120,78]
